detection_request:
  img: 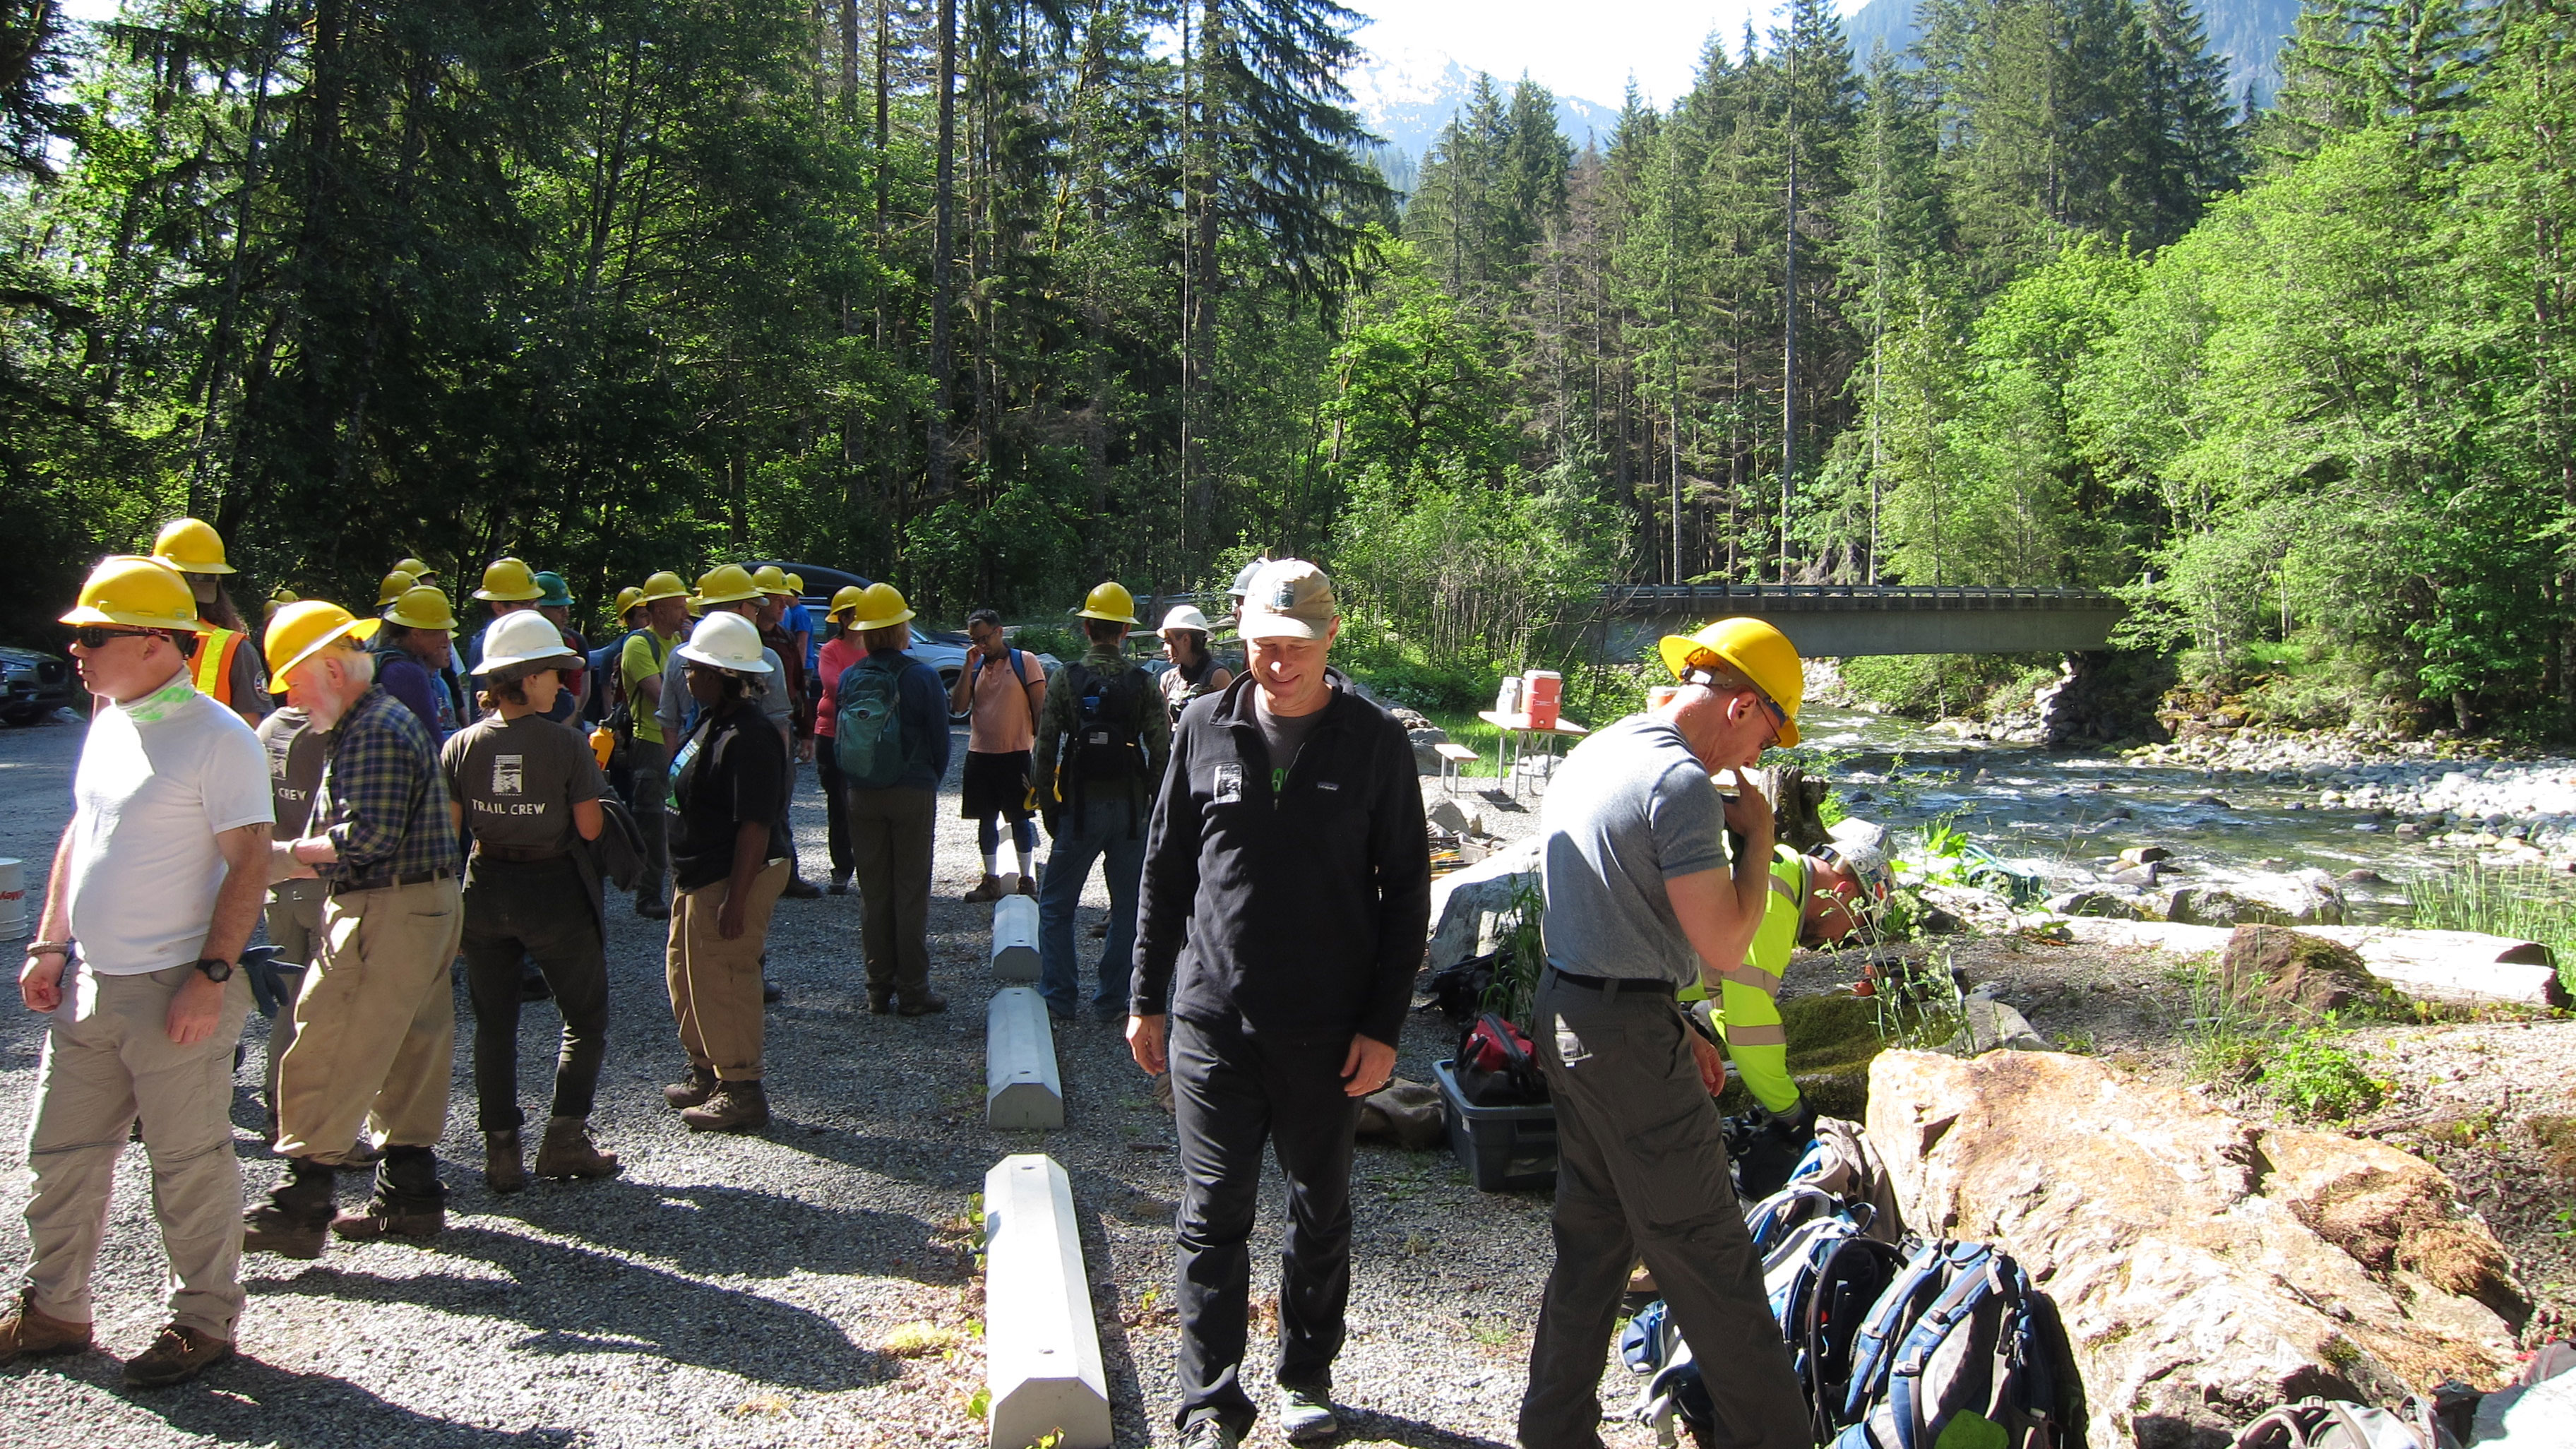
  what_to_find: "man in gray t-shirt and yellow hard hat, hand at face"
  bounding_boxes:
[1520,619,1811,1449]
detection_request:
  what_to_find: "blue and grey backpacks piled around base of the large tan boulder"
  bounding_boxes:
[1621,1116,2576,1449]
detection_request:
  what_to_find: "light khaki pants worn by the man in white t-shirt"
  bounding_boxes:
[23,967,250,1343]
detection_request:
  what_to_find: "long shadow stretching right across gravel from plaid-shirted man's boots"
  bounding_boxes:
[245,1224,894,1393]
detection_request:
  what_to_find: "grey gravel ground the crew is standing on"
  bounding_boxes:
[0,717,1649,1449]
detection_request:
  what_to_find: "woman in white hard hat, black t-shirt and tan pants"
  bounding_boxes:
[662,614,794,1132]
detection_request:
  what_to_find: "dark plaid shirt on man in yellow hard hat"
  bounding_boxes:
[306,686,458,884]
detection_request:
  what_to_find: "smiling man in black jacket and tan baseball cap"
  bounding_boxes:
[1128,559,1432,1449]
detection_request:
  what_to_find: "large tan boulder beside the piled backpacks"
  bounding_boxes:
[1868,1052,2522,1449]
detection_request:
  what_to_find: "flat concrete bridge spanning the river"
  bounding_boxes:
[1599,583,2128,660]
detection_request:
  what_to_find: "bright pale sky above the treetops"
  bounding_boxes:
[1342,0,1813,108]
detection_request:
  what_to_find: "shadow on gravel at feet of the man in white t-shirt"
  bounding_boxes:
[21,1354,580,1449]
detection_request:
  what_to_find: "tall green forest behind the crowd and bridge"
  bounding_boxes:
[15,0,2576,737]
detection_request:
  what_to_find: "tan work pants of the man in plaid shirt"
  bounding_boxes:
[278,876,468,1163]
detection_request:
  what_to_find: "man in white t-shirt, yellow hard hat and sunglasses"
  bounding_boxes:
[0,557,273,1387]
